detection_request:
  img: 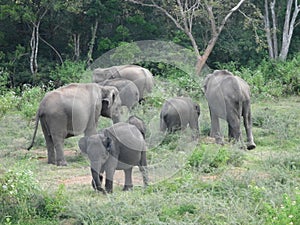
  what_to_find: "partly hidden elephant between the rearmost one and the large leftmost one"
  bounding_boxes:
[98,78,140,110]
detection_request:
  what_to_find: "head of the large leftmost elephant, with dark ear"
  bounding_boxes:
[101,86,122,123]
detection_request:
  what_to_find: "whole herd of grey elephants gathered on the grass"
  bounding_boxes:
[28,65,256,193]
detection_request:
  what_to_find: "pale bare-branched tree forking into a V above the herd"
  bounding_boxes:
[127,0,246,74]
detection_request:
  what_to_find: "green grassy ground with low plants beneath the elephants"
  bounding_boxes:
[0,89,300,225]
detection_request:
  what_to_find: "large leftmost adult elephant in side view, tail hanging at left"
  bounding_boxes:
[28,83,121,166]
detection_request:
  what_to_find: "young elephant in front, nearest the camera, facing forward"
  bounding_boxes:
[78,122,148,193]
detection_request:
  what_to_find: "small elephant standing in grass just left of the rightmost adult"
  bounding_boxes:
[160,97,200,137]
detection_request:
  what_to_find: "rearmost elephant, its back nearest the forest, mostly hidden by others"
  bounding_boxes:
[93,65,154,100]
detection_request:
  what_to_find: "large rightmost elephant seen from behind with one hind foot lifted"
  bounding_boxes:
[204,70,256,150]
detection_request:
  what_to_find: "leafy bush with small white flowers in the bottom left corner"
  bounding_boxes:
[0,163,66,224]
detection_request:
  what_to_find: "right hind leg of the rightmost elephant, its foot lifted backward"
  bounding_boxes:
[242,102,256,150]
